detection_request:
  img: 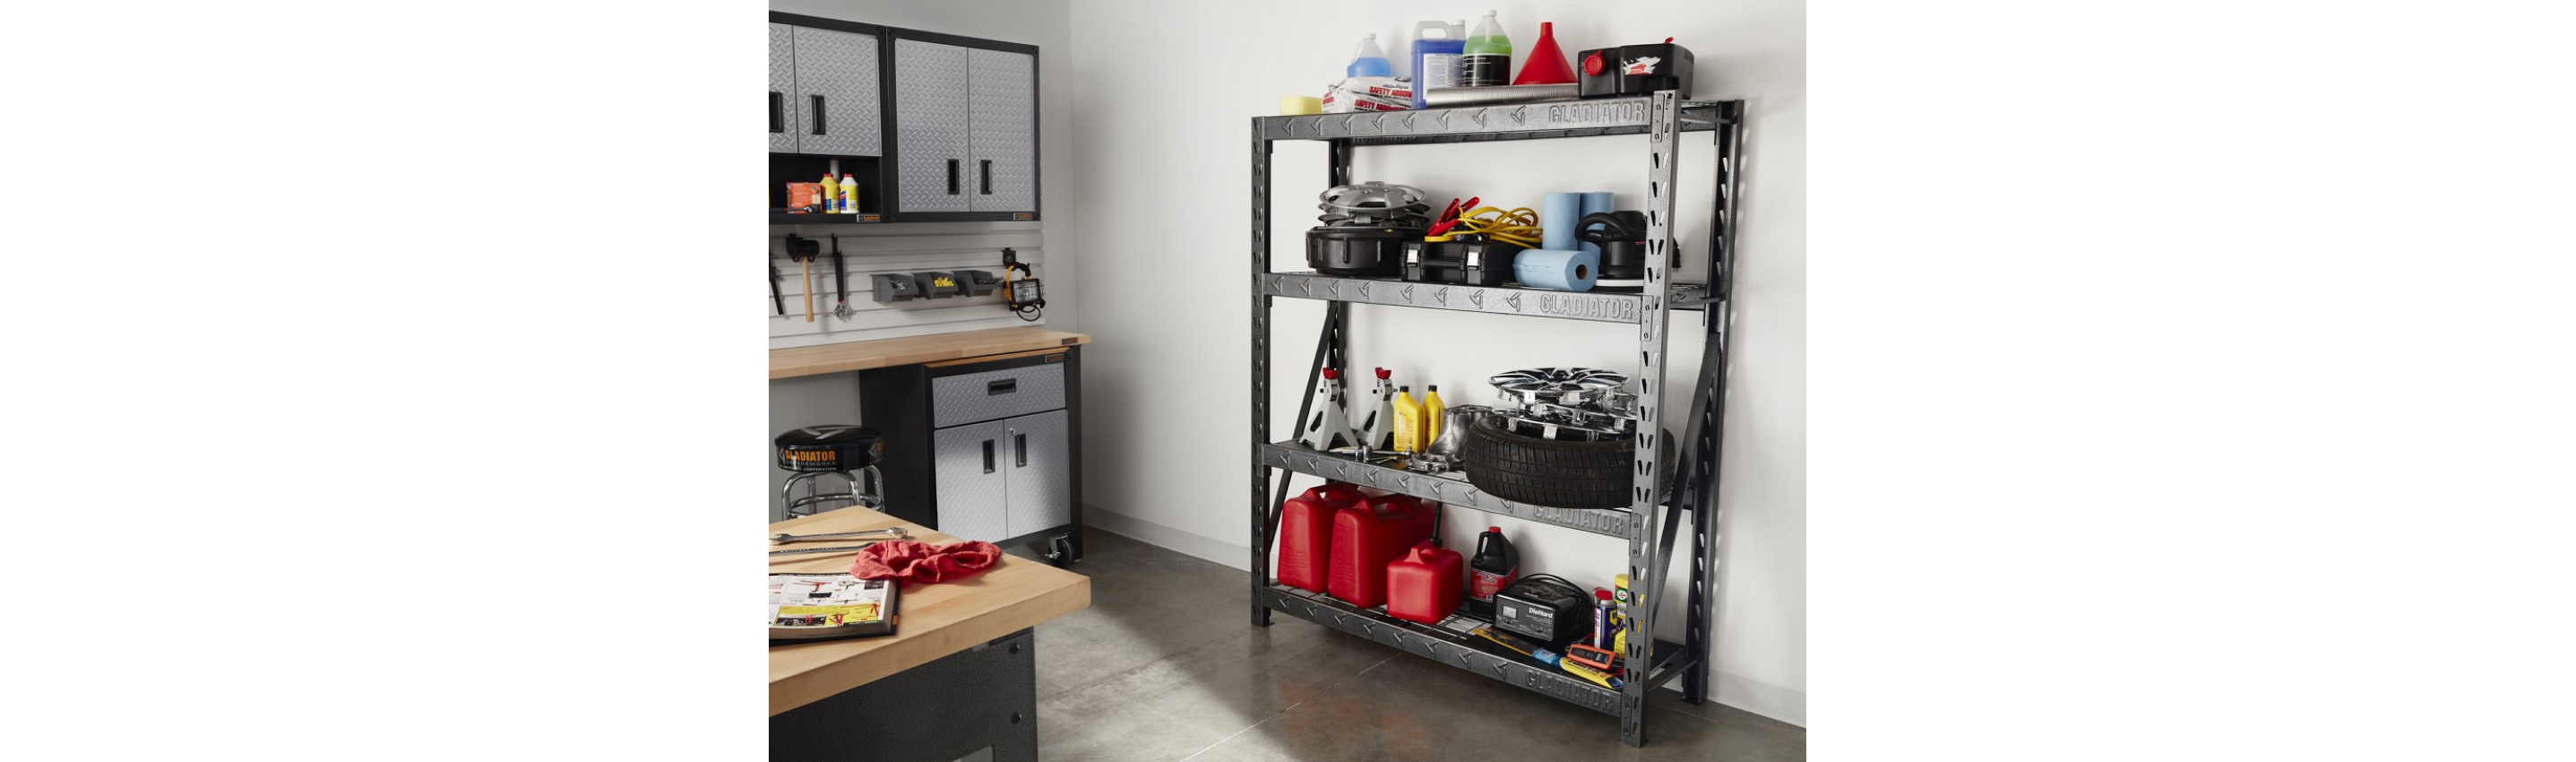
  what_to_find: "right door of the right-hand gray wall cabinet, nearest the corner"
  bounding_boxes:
[966,49,1038,211]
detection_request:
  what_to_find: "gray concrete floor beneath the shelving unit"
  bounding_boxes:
[1015,531,1805,762]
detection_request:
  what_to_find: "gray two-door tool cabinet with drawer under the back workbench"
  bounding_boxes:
[857,348,1082,567]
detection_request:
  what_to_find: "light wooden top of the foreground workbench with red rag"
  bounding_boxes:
[771,507,1092,715]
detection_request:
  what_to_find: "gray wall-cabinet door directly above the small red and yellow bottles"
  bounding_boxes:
[794,26,883,157]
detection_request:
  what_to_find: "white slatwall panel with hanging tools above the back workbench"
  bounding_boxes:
[760,221,1046,351]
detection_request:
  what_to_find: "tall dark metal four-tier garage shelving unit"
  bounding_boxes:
[1252,91,1744,747]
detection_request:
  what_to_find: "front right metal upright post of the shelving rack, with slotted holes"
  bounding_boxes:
[1618,91,1682,747]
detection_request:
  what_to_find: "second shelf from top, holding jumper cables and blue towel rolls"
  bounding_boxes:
[1262,273,1705,325]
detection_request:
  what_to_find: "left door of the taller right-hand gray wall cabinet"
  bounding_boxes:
[894,39,969,211]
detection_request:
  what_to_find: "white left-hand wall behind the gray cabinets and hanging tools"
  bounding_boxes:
[767,0,1082,512]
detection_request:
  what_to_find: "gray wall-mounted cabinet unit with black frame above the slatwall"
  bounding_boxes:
[768,13,1038,224]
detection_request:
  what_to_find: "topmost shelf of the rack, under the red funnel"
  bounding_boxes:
[1260,98,1739,144]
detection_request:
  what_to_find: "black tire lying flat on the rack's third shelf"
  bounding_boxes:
[1458,414,1675,507]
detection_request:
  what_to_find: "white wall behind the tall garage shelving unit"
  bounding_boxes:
[1056,0,1805,723]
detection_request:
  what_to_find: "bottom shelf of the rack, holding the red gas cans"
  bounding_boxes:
[1262,584,1690,715]
